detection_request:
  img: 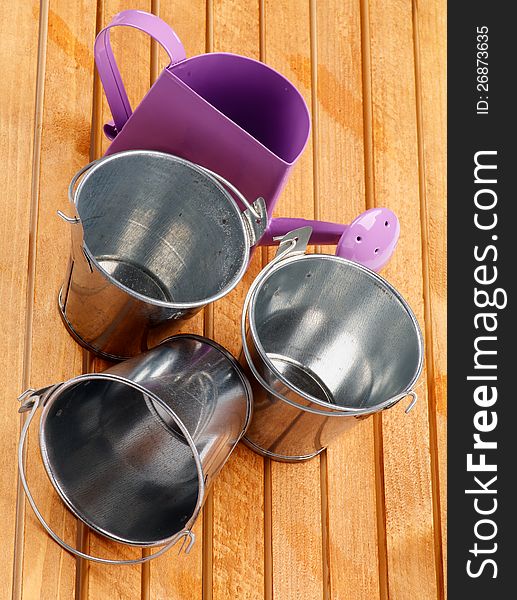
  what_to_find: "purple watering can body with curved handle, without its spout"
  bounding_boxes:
[95,10,310,223]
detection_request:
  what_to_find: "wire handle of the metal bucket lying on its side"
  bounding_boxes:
[18,384,196,565]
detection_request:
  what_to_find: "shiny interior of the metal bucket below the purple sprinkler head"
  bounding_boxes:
[250,255,421,408]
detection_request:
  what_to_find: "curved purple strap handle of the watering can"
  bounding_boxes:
[94,10,186,139]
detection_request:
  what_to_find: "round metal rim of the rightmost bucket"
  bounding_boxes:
[248,253,424,417]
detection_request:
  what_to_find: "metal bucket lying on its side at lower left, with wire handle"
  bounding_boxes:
[18,335,252,564]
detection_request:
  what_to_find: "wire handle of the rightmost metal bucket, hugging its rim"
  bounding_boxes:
[241,226,418,416]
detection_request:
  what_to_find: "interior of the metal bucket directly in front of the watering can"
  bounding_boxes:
[76,151,249,303]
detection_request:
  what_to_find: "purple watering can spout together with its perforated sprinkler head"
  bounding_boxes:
[259,208,400,271]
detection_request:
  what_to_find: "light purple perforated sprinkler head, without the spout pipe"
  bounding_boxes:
[336,208,400,271]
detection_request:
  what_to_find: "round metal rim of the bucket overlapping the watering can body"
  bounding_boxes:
[73,149,250,310]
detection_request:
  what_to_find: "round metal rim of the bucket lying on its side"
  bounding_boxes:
[38,373,206,548]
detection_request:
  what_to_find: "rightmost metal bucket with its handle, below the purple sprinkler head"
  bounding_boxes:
[241,228,423,461]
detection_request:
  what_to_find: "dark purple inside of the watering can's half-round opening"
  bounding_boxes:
[171,53,310,163]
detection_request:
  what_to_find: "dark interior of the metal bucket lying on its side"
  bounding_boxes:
[40,380,200,545]
